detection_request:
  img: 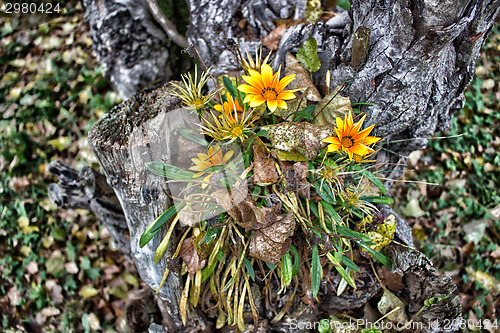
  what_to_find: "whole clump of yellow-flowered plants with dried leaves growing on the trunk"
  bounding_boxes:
[140,38,396,331]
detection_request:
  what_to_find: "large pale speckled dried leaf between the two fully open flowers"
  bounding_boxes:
[261,122,334,160]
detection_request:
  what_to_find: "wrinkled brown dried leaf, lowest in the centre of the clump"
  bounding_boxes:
[249,211,295,264]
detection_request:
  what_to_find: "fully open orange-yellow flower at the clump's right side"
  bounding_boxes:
[323,111,380,160]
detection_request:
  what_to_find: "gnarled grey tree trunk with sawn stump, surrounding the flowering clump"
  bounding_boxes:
[78,0,500,332]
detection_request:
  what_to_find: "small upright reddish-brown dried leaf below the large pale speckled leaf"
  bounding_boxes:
[252,138,279,186]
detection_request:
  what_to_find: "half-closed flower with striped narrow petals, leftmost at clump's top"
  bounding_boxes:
[171,67,216,111]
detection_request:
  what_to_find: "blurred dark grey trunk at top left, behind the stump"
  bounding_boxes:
[83,0,171,99]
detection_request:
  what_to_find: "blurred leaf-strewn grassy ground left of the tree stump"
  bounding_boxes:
[0,2,140,332]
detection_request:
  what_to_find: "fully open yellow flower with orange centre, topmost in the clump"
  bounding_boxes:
[238,64,297,112]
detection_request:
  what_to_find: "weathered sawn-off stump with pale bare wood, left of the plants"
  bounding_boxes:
[89,84,209,332]
